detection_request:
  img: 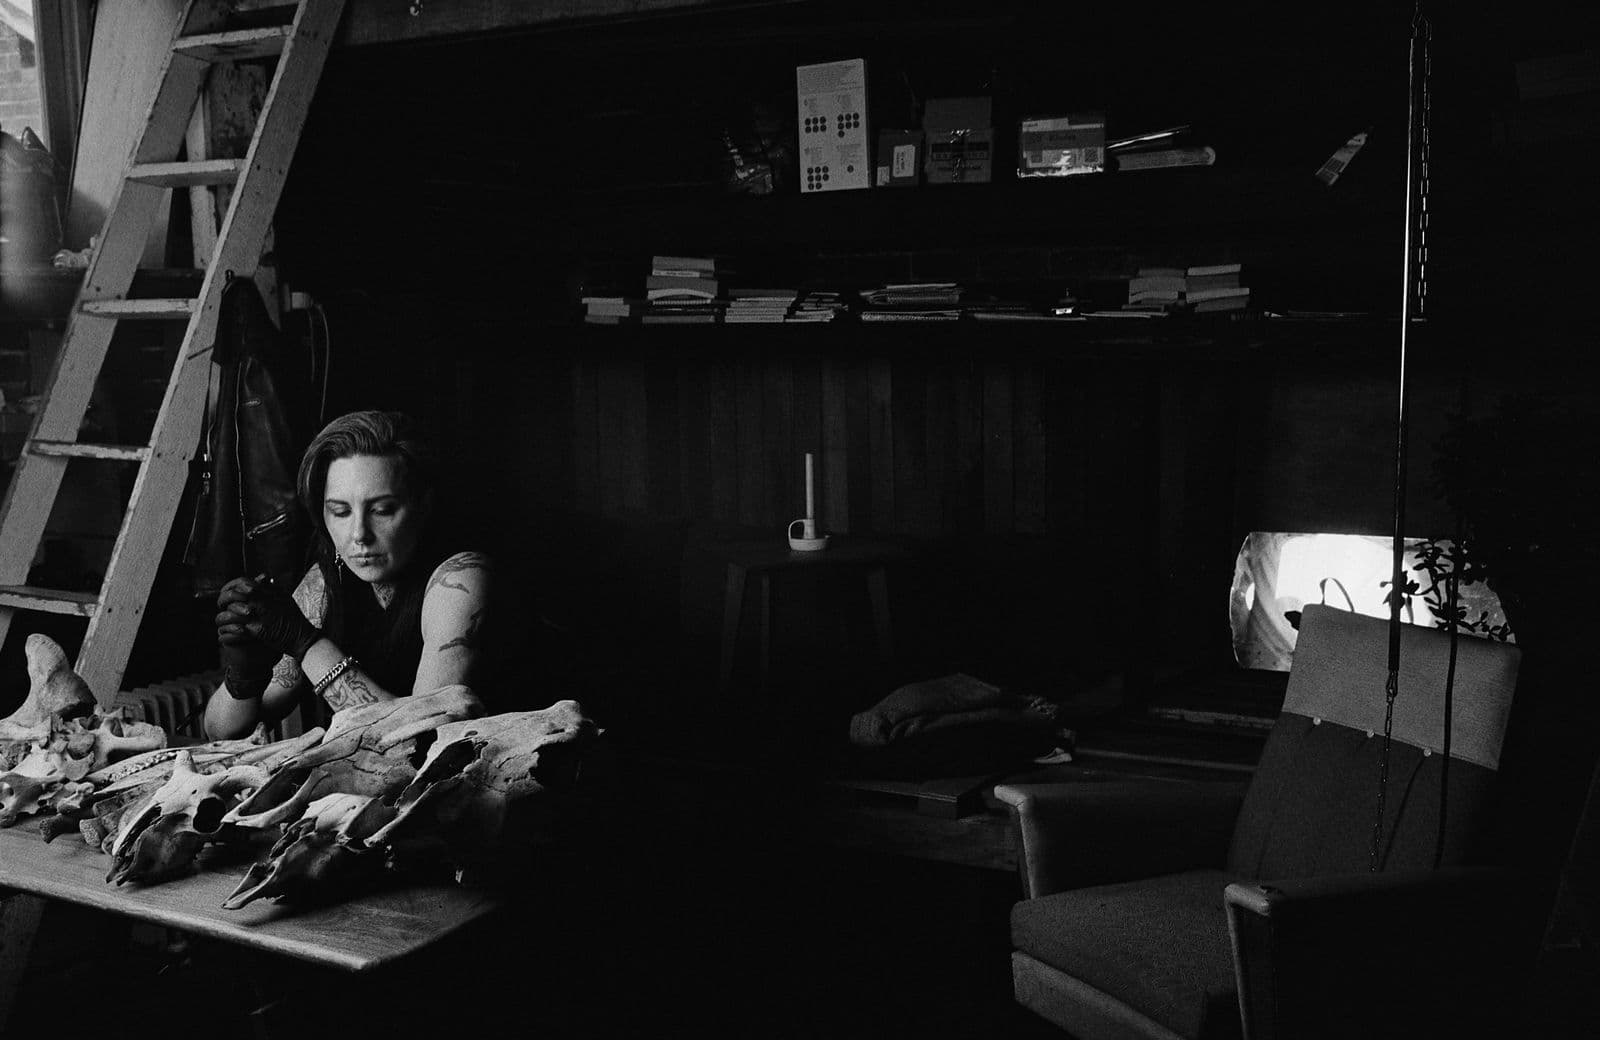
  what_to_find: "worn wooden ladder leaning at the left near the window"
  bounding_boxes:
[0,0,344,706]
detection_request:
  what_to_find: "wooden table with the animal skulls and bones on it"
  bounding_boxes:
[0,819,499,1030]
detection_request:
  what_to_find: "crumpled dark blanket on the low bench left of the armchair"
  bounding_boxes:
[850,672,1056,747]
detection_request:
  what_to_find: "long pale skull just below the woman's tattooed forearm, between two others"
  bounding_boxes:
[227,685,483,829]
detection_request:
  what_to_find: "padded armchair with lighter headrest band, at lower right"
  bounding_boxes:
[995,606,1520,1040]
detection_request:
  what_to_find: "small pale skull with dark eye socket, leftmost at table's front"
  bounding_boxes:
[106,750,267,885]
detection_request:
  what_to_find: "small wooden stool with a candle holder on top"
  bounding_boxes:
[710,536,909,690]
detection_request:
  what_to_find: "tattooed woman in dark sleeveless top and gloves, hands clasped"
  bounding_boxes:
[205,411,490,739]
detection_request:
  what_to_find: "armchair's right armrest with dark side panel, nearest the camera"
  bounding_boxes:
[1224,867,1531,1040]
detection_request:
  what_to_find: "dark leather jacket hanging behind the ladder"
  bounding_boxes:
[184,277,309,600]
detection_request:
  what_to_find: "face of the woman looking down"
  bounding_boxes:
[322,454,424,582]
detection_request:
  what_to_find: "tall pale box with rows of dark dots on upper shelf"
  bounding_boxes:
[795,58,872,195]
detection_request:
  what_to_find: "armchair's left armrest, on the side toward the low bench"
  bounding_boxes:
[995,781,1245,899]
